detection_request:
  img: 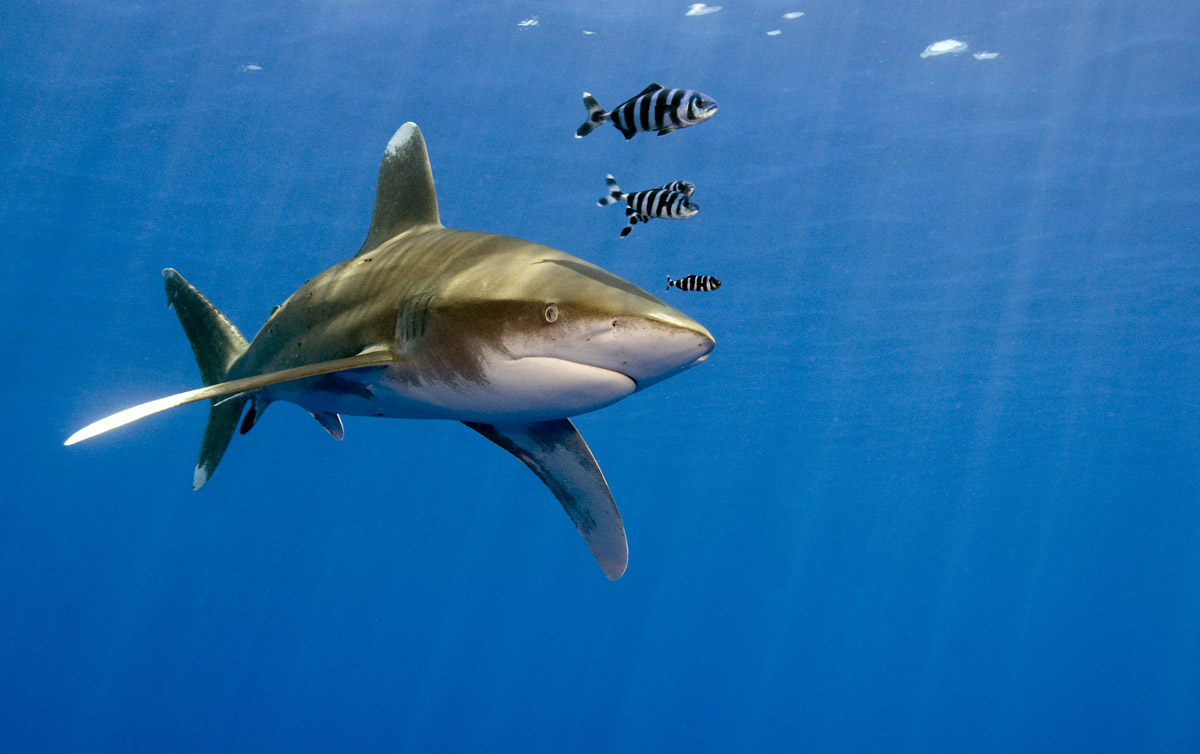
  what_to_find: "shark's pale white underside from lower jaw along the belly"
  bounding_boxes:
[282,357,637,424]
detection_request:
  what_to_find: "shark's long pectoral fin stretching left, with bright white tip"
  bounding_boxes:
[64,348,397,445]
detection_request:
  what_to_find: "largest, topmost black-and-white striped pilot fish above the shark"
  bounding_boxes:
[575,84,716,139]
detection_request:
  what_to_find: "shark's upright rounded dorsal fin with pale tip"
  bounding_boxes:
[354,122,442,256]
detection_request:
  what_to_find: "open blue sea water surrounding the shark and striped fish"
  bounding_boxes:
[0,0,1200,752]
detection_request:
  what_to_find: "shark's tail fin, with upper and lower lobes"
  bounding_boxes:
[162,268,248,490]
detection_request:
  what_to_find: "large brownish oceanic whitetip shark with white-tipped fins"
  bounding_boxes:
[66,122,714,579]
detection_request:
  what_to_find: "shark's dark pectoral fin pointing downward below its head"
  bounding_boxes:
[463,419,629,581]
